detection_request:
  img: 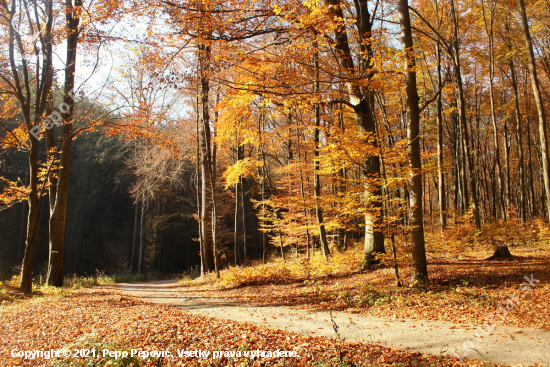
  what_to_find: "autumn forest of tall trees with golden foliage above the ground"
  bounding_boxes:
[0,0,550,365]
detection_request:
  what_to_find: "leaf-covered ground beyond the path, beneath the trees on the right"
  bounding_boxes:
[180,248,550,329]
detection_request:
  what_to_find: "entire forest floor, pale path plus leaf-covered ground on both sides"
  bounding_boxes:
[0,248,550,366]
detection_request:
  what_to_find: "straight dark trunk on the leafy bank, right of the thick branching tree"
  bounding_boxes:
[399,0,428,283]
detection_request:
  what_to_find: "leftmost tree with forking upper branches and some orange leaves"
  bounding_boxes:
[0,0,53,293]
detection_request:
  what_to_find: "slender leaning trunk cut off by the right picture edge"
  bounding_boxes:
[517,0,550,218]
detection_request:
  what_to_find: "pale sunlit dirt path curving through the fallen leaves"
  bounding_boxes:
[109,280,550,367]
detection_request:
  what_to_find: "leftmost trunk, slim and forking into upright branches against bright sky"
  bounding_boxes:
[7,0,53,293]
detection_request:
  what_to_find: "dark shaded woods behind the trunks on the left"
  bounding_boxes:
[0,128,200,280]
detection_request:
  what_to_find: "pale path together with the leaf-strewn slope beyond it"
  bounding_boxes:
[110,248,550,366]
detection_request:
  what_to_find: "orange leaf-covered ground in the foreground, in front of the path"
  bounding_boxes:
[0,288,504,366]
